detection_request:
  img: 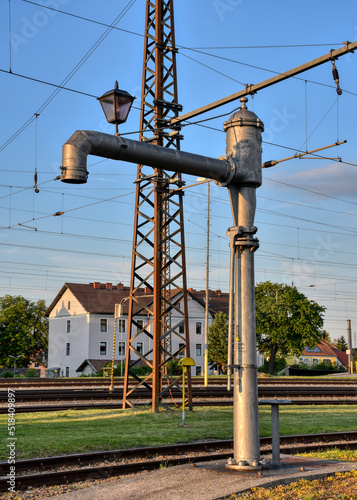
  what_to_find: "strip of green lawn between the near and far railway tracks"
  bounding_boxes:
[0,405,357,460]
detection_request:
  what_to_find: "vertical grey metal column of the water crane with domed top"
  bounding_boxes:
[224,97,264,470]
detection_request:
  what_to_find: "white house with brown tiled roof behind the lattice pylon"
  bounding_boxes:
[46,282,261,377]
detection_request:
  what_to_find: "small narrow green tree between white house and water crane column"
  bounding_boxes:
[208,311,228,372]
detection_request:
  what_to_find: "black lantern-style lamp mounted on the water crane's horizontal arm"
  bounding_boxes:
[98,81,136,135]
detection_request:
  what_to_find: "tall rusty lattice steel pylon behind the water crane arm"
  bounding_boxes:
[123,0,192,412]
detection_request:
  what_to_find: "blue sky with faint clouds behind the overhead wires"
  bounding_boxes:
[0,0,357,338]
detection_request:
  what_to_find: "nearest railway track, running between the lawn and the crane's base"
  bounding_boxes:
[0,432,357,491]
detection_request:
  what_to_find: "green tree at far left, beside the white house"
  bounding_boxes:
[0,295,48,366]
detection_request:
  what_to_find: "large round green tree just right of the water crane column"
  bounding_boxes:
[255,281,325,375]
